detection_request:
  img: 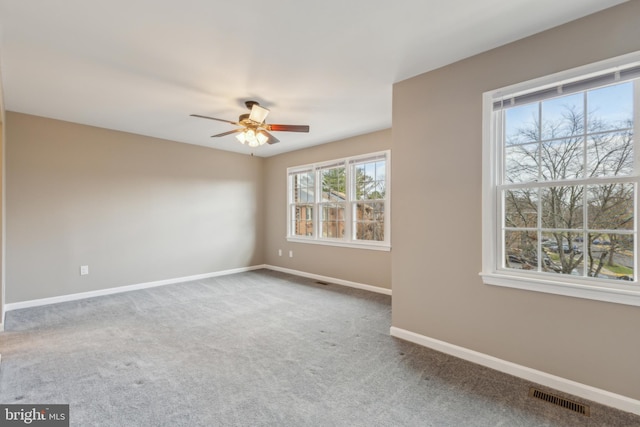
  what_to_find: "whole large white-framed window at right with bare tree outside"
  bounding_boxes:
[482,54,640,305]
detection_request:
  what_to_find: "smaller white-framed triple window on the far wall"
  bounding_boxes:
[287,151,391,250]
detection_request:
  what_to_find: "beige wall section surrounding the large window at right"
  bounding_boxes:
[392,1,640,399]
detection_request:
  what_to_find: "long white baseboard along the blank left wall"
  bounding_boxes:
[4,265,266,312]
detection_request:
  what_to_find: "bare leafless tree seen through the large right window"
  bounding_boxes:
[504,106,634,276]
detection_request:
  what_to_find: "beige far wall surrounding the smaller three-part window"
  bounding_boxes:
[264,129,394,289]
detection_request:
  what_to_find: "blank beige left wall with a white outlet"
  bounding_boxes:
[5,112,264,303]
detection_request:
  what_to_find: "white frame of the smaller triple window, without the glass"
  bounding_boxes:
[286,150,391,251]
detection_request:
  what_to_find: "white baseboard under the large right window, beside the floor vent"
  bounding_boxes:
[390,326,640,415]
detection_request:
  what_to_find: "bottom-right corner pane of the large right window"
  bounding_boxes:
[588,233,635,281]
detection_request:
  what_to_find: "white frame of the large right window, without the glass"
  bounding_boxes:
[480,52,640,306]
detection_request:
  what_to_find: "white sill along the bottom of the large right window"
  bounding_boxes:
[480,272,640,307]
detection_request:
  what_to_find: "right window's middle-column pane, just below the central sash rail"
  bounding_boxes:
[540,186,584,229]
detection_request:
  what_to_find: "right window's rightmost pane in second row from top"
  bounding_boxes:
[587,130,633,177]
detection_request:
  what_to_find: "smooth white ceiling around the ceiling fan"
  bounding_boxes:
[0,0,624,156]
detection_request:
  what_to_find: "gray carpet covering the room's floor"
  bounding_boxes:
[0,270,640,427]
